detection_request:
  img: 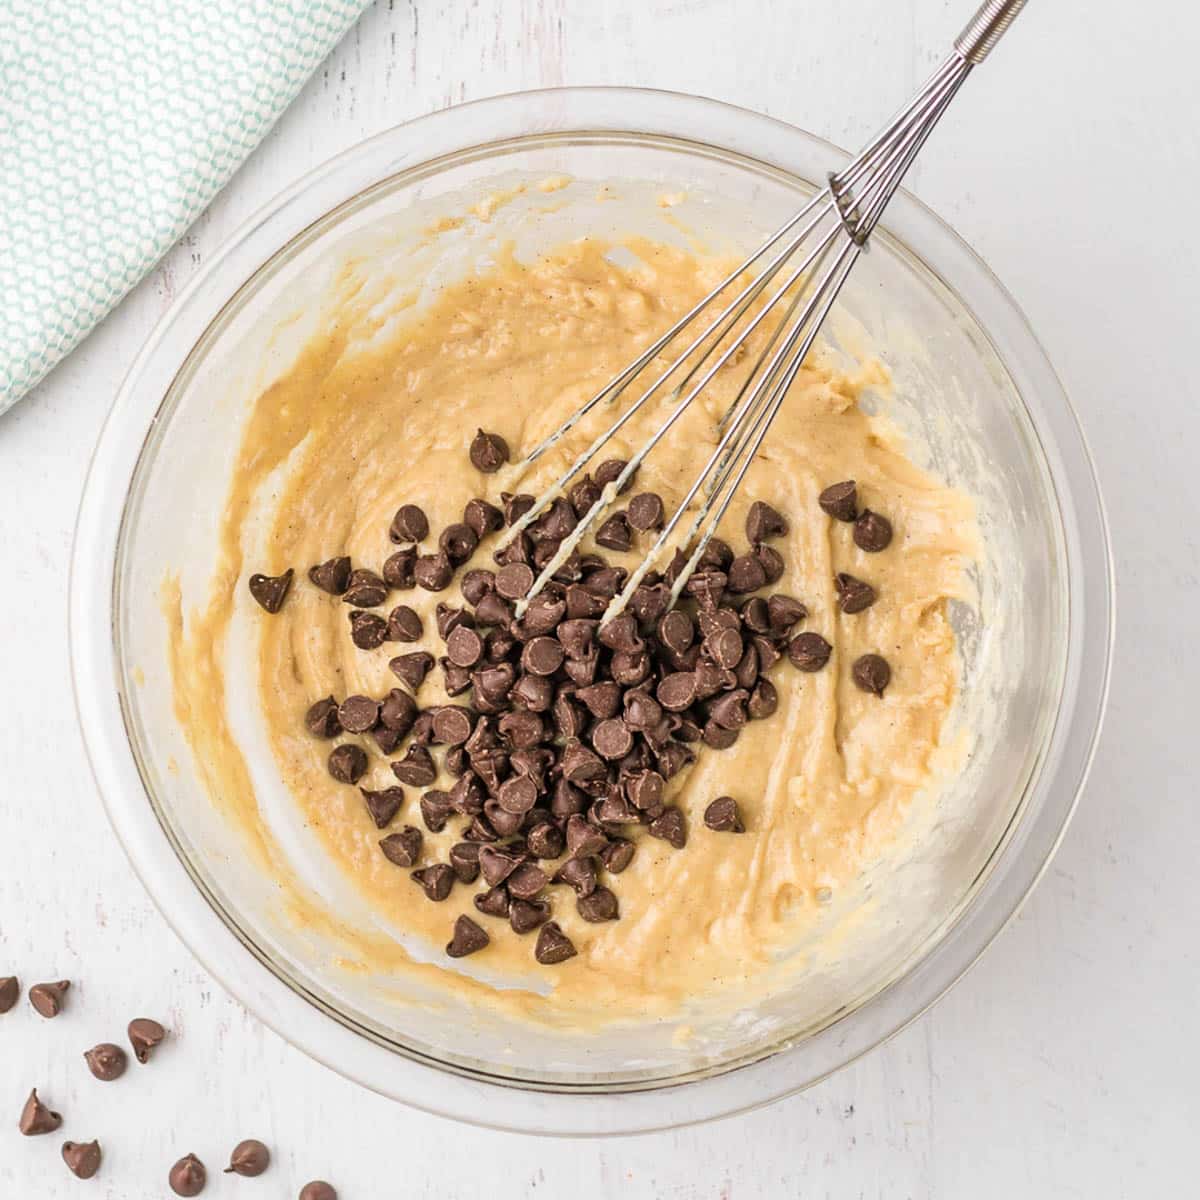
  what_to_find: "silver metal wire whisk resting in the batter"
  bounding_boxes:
[503,0,1025,622]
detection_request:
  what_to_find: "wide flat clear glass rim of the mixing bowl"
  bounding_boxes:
[70,88,1114,1135]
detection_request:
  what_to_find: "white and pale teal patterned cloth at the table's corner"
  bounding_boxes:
[0,0,366,412]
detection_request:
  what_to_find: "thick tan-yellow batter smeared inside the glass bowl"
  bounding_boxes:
[172,231,974,1025]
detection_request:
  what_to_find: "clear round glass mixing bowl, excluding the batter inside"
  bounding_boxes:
[71,89,1112,1134]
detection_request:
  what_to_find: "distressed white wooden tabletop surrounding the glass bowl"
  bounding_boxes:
[0,0,1200,1200]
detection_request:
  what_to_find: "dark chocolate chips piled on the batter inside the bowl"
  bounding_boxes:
[250,431,892,965]
